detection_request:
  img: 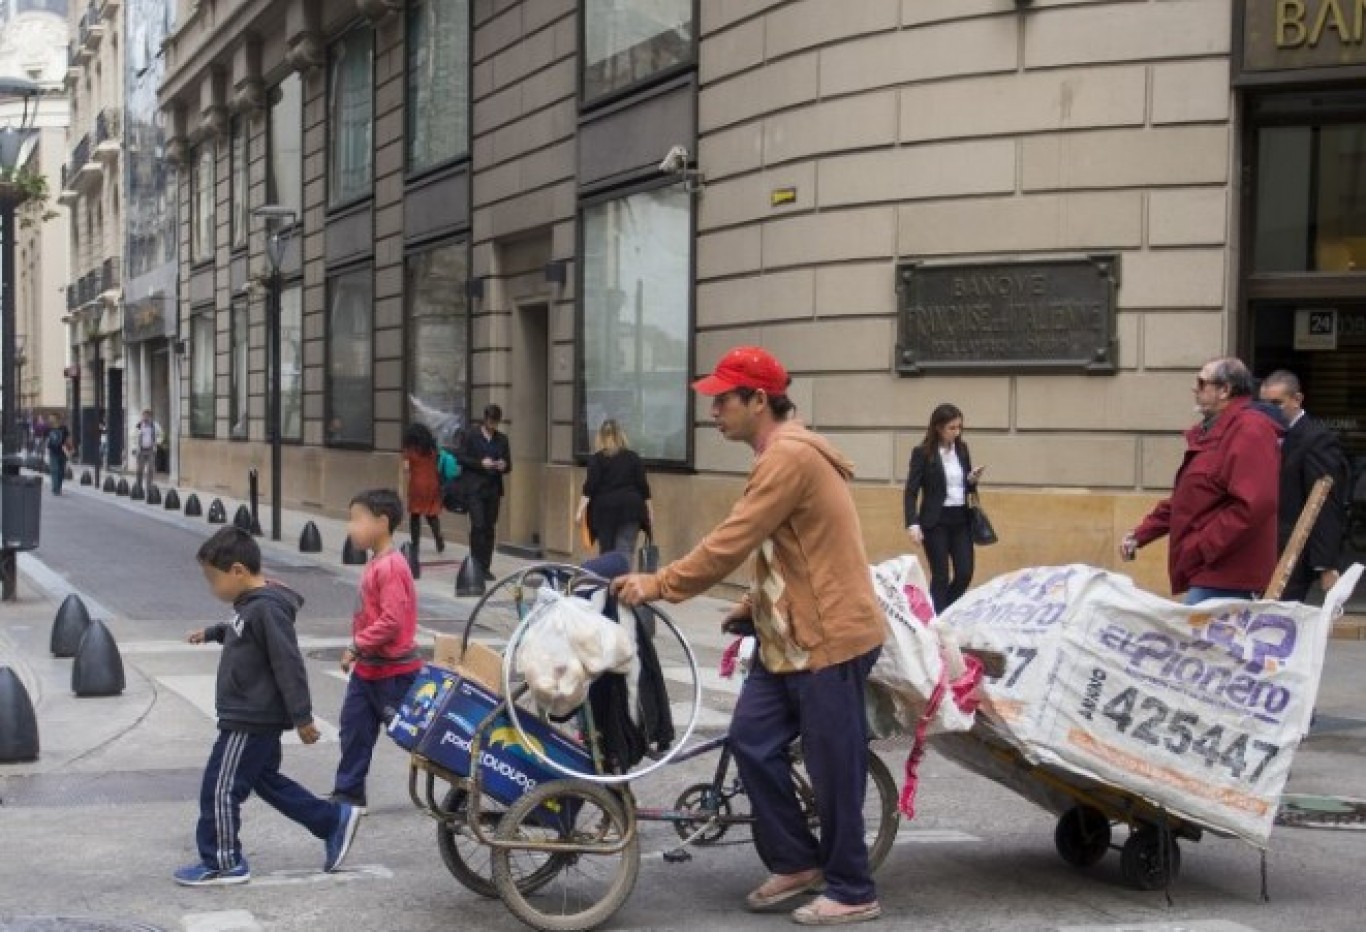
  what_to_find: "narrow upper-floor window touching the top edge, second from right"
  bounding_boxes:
[407,0,470,171]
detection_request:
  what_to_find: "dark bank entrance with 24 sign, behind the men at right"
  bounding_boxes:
[1239,96,1366,573]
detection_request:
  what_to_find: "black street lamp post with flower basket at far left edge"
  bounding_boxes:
[0,78,40,601]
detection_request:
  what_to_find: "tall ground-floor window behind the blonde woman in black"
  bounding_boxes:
[578,184,693,462]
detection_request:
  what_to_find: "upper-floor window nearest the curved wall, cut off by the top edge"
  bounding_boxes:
[583,0,693,101]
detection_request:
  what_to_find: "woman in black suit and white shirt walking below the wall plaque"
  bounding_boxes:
[906,405,986,612]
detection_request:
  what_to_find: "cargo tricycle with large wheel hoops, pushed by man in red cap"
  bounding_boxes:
[408,563,899,931]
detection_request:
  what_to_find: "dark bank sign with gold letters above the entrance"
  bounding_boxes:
[1242,0,1366,74]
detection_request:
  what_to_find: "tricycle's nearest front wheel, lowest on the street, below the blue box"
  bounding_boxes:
[493,780,641,932]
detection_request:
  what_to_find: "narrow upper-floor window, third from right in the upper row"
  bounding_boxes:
[328,27,374,206]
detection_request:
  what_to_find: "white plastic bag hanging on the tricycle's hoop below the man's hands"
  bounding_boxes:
[516,586,635,717]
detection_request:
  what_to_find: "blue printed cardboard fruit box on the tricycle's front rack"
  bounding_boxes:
[417,679,594,805]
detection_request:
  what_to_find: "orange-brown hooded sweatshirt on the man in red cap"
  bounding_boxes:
[646,422,885,674]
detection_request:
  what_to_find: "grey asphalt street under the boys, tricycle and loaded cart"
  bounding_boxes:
[0,483,1366,932]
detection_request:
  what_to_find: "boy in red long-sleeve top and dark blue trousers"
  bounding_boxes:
[332,489,422,812]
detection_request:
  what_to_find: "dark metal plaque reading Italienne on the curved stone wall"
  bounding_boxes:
[896,253,1119,376]
